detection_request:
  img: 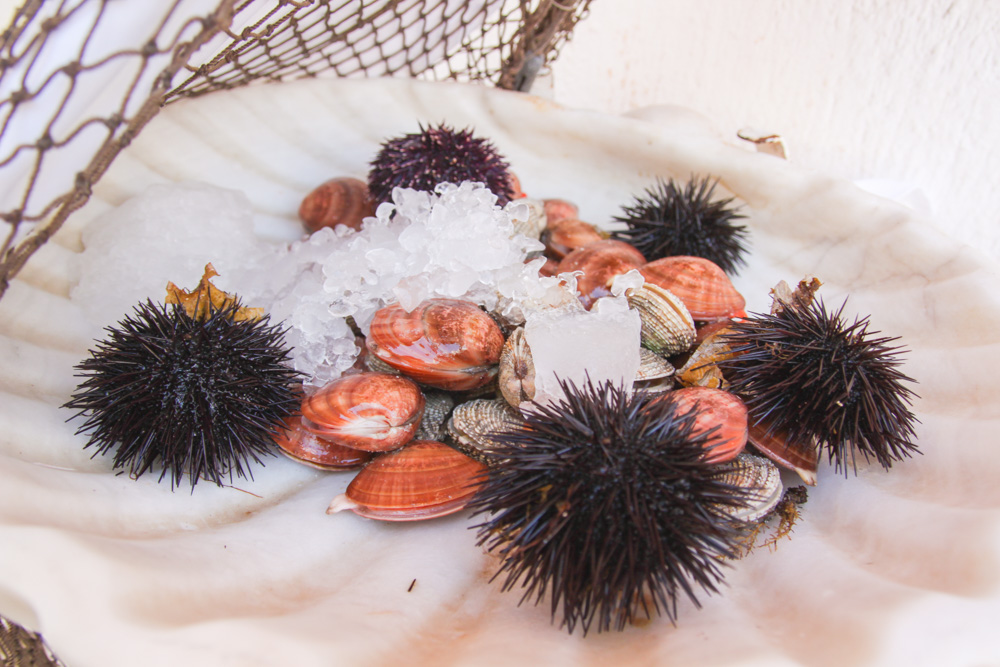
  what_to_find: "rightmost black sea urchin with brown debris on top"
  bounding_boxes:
[718,299,919,474]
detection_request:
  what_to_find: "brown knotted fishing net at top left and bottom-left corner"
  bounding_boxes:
[0,0,590,667]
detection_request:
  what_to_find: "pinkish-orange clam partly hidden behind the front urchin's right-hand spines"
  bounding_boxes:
[654,387,747,463]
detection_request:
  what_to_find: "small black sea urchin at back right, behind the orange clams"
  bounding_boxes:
[611,177,748,274]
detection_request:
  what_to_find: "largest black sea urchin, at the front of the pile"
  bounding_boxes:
[473,381,745,634]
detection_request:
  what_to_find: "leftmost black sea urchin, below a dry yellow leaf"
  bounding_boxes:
[64,301,299,490]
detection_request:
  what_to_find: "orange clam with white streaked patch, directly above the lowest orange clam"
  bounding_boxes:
[302,372,424,452]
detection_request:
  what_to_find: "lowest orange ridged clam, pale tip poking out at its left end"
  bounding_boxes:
[327,440,486,521]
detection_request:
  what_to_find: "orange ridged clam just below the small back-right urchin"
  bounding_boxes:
[639,255,746,320]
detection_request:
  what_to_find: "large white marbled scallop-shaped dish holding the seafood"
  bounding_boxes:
[7,78,1000,667]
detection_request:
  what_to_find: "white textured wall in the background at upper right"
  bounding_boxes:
[552,0,1000,259]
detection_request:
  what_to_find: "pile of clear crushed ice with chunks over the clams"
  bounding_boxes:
[72,183,641,394]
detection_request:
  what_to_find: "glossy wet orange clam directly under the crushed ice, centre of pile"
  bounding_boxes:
[366,299,504,391]
